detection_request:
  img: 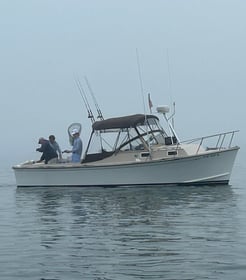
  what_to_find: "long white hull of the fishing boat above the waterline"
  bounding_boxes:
[13,147,239,187]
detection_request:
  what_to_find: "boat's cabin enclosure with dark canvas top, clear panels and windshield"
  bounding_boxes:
[82,114,177,163]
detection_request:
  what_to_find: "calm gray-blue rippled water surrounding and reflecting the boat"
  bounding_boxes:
[0,165,246,280]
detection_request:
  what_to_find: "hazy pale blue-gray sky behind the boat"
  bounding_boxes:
[0,0,246,164]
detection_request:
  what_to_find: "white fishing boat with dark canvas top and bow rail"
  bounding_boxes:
[13,106,239,187]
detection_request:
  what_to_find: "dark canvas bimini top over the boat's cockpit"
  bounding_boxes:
[92,114,159,131]
